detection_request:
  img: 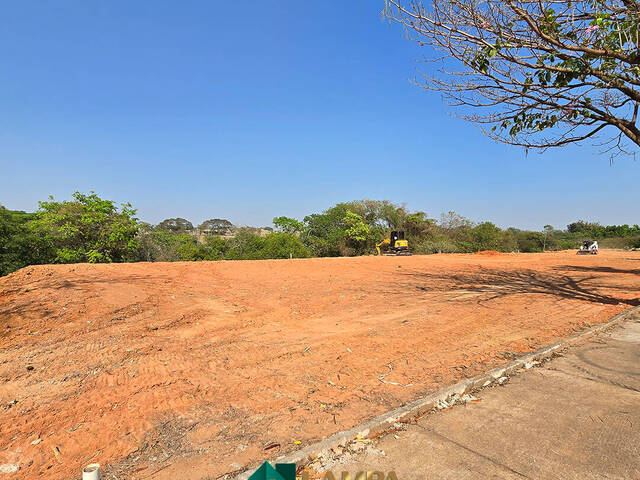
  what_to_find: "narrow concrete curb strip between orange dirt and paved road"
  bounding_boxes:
[228,306,640,480]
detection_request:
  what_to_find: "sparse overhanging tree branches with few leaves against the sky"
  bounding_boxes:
[385,0,640,153]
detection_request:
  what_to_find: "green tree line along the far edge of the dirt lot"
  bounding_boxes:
[0,192,640,275]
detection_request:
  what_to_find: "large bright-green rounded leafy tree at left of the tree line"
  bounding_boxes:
[32,192,139,263]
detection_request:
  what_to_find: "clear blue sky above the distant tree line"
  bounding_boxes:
[0,0,640,229]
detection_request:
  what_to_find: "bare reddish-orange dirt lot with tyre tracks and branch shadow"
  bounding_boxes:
[0,251,640,480]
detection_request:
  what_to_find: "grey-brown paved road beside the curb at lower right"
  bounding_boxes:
[331,312,640,480]
